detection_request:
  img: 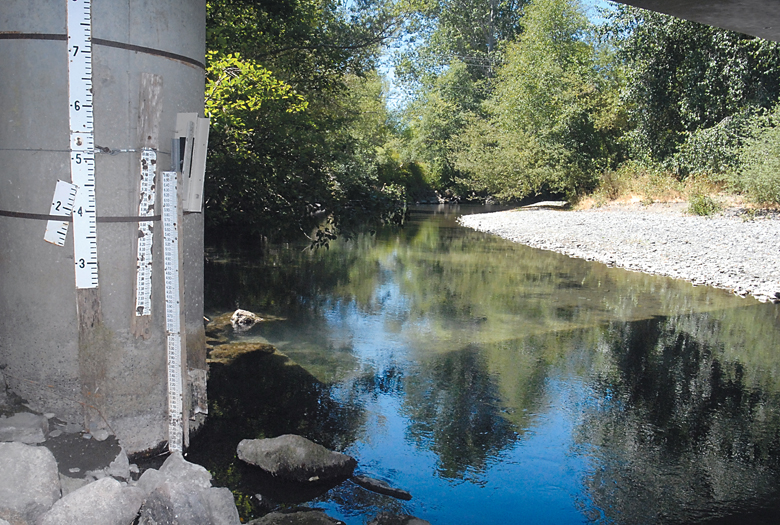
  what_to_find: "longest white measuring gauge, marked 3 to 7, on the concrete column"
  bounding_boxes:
[67,0,98,288]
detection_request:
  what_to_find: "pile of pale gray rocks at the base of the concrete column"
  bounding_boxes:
[0,412,240,525]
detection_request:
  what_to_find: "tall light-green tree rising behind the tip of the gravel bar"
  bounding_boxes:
[452,0,614,200]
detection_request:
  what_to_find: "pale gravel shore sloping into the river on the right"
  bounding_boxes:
[459,203,780,302]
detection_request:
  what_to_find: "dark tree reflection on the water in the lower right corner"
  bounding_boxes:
[579,316,780,523]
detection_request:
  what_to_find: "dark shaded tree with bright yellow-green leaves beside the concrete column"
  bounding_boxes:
[206,0,404,243]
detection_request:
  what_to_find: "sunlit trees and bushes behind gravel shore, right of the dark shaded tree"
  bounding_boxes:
[398,0,780,207]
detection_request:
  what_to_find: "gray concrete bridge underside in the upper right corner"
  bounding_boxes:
[619,0,780,41]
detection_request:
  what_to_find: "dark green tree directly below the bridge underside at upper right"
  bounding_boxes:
[606,6,780,161]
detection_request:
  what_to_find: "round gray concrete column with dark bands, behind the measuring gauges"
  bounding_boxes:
[0,0,206,453]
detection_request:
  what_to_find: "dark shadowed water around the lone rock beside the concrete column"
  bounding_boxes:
[188,352,362,504]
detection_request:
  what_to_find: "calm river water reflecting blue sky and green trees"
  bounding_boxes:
[190,206,780,525]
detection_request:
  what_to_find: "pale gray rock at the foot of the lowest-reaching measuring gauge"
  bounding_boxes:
[136,453,241,525]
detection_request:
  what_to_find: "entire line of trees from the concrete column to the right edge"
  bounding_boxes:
[206,0,780,244]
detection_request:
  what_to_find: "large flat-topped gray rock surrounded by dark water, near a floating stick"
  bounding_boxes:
[237,434,357,482]
